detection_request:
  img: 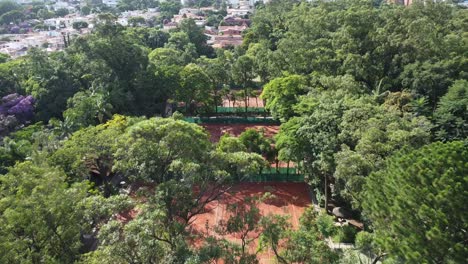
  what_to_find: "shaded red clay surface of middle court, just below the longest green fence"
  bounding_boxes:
[200,124,279,142]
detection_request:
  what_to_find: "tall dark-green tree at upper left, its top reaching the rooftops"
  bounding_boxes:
[69,25,157,115]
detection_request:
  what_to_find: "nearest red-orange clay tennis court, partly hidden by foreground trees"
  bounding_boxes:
[188,182,311,264]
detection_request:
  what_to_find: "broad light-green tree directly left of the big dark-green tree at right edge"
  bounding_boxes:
[334,93,433,208]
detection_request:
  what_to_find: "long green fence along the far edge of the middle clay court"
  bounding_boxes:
[185,117,280,125]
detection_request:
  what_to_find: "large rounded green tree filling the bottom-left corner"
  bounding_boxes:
[0,161,90,263]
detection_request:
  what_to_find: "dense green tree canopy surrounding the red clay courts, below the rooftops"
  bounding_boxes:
[0,0,468,264]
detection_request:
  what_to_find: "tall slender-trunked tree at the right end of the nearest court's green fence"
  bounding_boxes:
[277,90,347,209]
